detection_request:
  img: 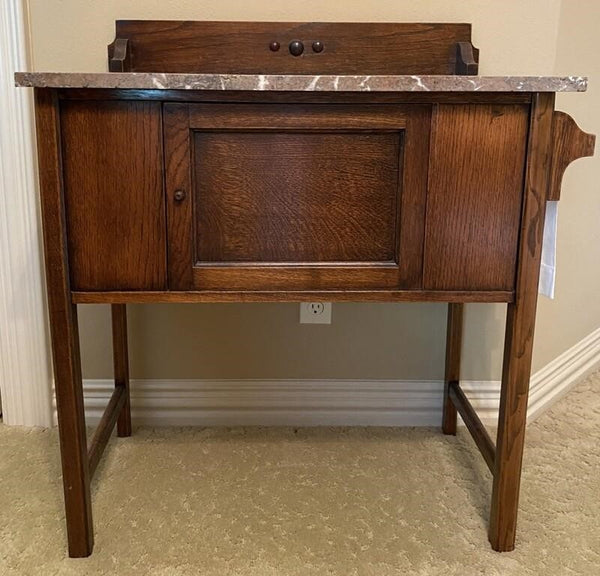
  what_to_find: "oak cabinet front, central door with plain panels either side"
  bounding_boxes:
[61,100,529,291]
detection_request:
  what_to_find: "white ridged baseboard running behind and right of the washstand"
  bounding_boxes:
[64,329,600,426]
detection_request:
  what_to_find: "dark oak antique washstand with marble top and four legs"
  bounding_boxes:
[16,21,594,556]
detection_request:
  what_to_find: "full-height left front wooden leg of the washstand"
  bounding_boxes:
[35,88,94,558]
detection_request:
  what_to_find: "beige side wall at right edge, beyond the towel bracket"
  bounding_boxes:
[534,0,600,368]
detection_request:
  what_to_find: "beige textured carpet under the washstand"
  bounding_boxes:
[0,373,600,576]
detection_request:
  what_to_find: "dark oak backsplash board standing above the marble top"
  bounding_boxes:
[109,20,471,74]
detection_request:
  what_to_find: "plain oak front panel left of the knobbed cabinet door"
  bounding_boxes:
[61,100,167,291]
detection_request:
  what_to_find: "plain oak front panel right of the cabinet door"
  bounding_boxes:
[423,104,529,291]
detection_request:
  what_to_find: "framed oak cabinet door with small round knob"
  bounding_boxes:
[164,103,430,290]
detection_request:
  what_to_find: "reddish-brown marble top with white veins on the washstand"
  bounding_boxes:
[15,72,587,92]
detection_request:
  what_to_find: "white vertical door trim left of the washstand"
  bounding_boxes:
[0,0,52,426]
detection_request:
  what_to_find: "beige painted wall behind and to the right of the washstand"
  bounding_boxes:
[29,0,600,380]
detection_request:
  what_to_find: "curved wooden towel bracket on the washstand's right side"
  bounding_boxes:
[548,112,596,200]
